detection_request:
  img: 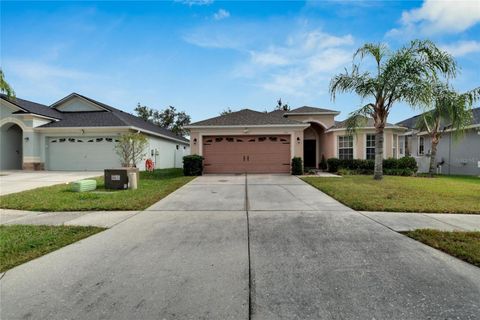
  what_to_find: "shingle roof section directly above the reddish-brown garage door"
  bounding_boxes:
[190,109,302,126]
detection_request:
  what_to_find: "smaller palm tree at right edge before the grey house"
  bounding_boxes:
[417,83,480,177]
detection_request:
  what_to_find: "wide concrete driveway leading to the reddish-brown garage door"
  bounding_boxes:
[0,175,480,319]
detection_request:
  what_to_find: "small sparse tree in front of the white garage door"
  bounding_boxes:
[115,132,148,167]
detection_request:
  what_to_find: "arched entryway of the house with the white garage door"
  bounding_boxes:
[0,122,23,170]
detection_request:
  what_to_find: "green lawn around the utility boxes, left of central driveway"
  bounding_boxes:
[0,169,194,212]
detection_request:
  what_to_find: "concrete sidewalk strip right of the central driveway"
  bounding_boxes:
[360,211,480,231]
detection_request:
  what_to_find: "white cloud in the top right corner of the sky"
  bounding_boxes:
[387,0,480,37]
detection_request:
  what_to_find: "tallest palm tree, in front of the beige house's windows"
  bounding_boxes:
[330,40,456,180]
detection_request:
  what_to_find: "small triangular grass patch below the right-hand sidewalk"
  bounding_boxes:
[402,229,480,267]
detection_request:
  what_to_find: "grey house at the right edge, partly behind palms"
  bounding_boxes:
[397,108,480,175]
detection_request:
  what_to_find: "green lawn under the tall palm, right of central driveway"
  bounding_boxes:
[303,175,480,214]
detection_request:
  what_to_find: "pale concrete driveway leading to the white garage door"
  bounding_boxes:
[0,170,103,196]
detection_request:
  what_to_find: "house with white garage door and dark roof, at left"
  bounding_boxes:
[0,93,190,170]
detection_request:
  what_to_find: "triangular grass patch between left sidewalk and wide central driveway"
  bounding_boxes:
[0,225,105,272]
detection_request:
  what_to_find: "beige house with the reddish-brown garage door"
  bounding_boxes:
[187,106,407,173]
